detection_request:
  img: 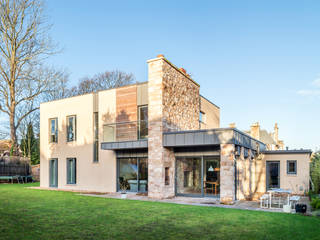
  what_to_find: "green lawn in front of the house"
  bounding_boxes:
[0,184,320,240]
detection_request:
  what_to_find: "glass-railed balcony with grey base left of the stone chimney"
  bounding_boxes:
[101,121,148,150]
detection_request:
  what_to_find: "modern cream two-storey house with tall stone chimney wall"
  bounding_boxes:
[40,55,310,203]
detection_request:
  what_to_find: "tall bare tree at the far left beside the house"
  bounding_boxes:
[0,0,55,150]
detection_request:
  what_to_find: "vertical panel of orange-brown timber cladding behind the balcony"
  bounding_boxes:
[116,85,137,141]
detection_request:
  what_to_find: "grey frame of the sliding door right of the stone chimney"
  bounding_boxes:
[174,155,221,198]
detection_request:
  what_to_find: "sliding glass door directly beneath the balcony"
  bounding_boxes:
[117,158,148,192]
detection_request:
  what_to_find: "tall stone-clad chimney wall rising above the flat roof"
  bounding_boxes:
[148,57,200,198]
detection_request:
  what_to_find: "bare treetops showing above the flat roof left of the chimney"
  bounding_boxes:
[70,70,134,96]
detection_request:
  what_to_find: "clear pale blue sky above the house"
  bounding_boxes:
[7,0,320,149]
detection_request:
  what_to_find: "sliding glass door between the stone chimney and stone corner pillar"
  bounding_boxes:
[176,157,220,197]
